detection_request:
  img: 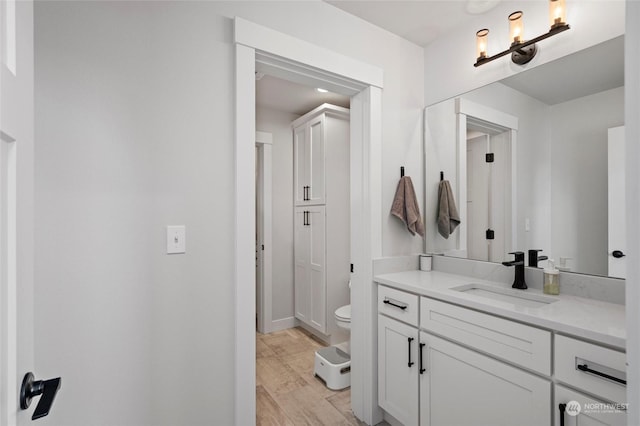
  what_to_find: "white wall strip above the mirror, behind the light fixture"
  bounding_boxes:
[424,0,625,105]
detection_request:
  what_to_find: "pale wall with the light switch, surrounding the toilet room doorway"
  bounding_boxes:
[35,1,424,425]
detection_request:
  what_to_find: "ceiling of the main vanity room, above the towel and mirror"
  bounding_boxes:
[325,0,500,46]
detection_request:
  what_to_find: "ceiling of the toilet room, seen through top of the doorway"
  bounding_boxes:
[256,75,350,115]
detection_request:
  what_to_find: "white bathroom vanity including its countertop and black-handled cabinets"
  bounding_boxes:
[374,270,626,426]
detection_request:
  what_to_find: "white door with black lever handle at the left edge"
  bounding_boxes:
[0,0,55,426]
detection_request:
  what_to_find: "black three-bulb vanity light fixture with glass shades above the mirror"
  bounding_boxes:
[473,0,570,67]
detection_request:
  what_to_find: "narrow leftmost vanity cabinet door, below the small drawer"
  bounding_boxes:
[378,315,418,426]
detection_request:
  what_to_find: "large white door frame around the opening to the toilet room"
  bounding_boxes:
[234,17,383,425]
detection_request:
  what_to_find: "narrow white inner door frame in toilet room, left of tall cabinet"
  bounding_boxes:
[256,132,273,333]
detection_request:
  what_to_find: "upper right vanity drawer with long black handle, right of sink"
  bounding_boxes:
[554,335,627,403]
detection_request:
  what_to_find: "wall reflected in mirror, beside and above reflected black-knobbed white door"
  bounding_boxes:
[549,87,624,275]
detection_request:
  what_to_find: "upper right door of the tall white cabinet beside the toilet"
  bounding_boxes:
[306,114,325,204]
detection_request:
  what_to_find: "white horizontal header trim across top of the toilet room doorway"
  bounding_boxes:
[234,17,383,87]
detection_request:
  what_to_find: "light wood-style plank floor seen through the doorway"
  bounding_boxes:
[256,328,364,426]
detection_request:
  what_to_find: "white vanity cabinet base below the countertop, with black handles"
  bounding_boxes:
[378,281,626,426]
